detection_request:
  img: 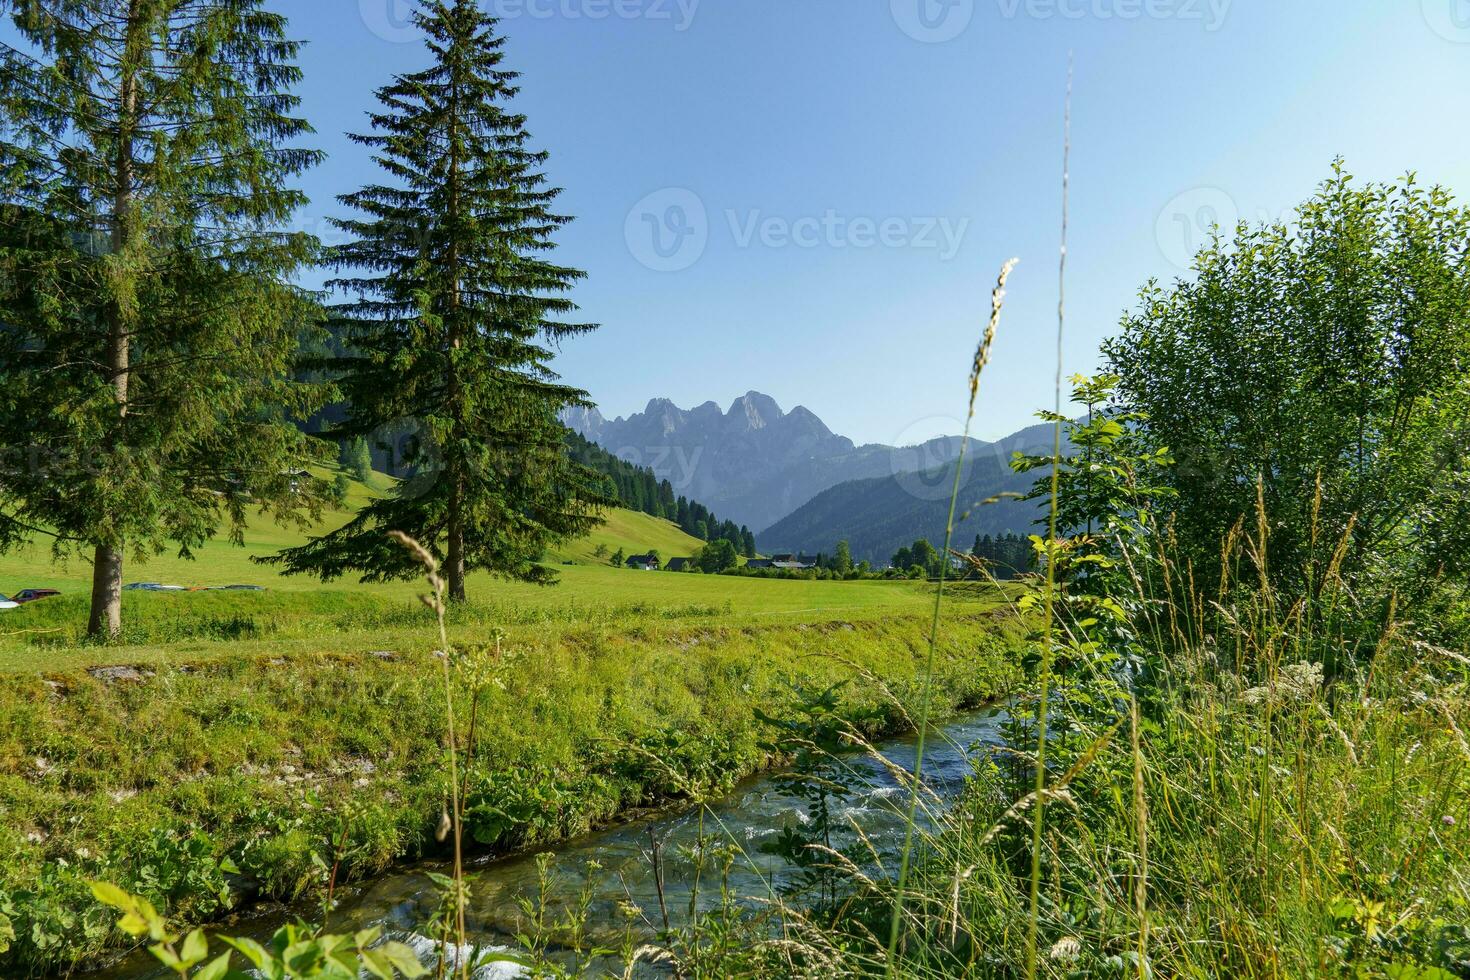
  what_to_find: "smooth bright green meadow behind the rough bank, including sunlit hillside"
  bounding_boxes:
[0,485,986,671]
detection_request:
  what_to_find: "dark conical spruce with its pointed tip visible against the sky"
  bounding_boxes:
[276,0,612,601]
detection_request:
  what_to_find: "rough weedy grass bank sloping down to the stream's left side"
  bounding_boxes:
[0,605,1019,976]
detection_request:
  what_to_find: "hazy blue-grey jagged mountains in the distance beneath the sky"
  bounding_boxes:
[563,391,1051,561]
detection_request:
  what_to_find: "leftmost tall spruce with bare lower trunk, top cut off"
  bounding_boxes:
[0,0,325,635]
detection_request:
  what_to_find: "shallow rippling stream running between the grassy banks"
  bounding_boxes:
[90,708,1004,980]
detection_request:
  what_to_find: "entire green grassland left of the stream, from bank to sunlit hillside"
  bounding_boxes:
[0,470,1022,977]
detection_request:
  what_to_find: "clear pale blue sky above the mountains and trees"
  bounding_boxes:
[17,0,1470,442]
